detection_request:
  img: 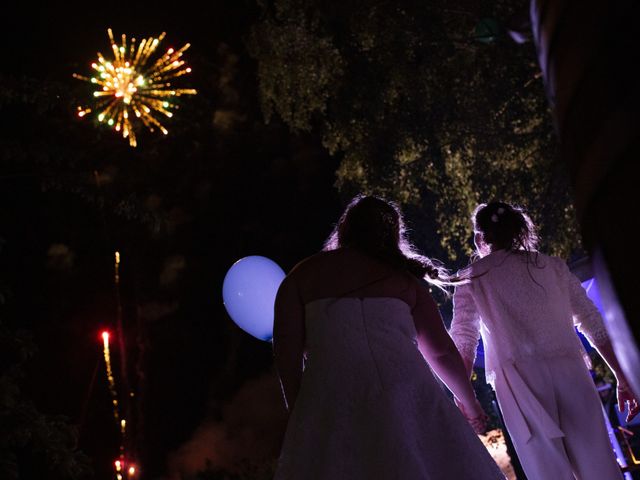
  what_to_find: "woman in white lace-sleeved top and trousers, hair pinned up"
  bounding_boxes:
[450,202,639,480]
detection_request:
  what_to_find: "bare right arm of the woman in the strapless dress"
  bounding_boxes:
[413,286,484,418]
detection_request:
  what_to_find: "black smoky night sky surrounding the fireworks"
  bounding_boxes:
[0,1,344,479]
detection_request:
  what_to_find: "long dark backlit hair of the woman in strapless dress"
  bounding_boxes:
[323,195,449,289]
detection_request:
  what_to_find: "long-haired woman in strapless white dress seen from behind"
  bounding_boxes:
[274,197,504,480]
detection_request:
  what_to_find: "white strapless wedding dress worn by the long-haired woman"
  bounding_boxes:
[275,297,504,480]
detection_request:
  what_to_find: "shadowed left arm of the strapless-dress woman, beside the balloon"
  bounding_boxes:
[273,276,305,412]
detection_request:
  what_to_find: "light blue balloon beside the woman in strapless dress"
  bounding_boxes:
[222,255,285,341]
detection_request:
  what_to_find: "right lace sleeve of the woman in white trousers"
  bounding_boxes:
[560,261,609,347]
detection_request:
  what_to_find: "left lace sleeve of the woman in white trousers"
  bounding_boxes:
[449,285,480,362]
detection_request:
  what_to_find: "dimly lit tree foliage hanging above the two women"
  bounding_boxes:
[248,0,577,260]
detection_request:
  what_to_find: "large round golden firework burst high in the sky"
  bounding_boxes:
[73,29,196,147]
